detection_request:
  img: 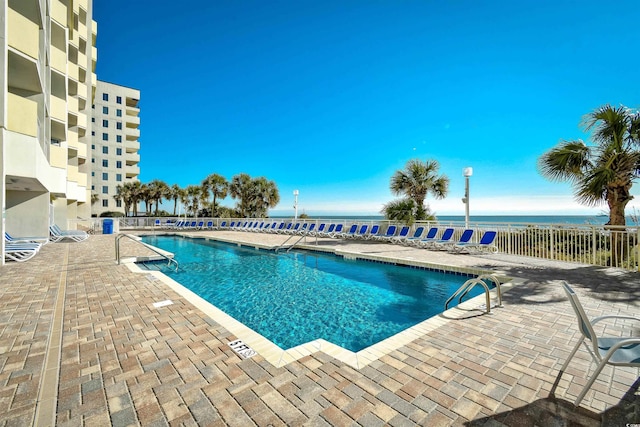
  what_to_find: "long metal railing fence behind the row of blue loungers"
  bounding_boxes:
[112,217,640,271]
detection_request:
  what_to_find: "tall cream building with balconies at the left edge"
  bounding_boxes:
[0,0,97,263]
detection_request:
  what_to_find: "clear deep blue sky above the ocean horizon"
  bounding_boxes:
[94,0,640,215]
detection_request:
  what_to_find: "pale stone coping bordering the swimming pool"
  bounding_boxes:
[122,233,518,369]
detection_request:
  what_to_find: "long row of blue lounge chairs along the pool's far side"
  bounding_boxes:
[208,221,497,252]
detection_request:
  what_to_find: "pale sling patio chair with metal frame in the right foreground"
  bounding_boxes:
[556,282,640,406]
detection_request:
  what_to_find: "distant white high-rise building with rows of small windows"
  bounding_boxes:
[91,81,140,216]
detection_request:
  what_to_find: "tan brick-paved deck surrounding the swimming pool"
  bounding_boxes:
[0,231,640,427]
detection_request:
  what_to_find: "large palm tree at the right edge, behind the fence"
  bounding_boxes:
[538,104,640,226]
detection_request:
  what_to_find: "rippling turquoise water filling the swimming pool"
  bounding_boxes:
[143,236,480,351]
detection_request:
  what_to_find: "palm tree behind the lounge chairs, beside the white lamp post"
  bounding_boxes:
[382,159,449,222]
